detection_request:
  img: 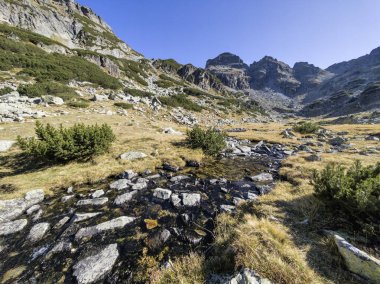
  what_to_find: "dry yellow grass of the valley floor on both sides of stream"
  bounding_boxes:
[0,105,380,283]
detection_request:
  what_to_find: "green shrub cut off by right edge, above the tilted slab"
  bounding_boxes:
[312,161,380,234]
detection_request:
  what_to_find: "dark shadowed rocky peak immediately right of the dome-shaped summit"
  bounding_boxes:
[248,56,301,96]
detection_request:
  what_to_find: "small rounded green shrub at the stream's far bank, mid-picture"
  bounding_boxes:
[186,126,226,156]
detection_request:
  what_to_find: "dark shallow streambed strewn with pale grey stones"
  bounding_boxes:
[0,139,291,283]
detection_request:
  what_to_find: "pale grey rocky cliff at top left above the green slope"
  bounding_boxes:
[0,0,136,58]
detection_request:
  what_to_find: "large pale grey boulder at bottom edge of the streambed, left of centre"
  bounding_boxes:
[73,244,119,284]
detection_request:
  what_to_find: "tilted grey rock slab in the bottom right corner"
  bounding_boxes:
[334,235,380,283]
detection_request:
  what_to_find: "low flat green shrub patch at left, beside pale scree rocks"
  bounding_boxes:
[17,82,78,101]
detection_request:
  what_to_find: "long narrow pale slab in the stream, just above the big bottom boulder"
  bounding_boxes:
[75,216,136,240]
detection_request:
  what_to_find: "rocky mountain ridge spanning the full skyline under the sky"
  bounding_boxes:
[0,0,380,116]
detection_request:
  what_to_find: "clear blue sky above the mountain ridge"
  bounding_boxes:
[78,0,380,68]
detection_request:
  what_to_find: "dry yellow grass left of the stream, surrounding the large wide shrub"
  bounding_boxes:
[0,107,203,198]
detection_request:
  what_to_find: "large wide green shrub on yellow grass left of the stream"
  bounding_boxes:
[17,122,115,162]
